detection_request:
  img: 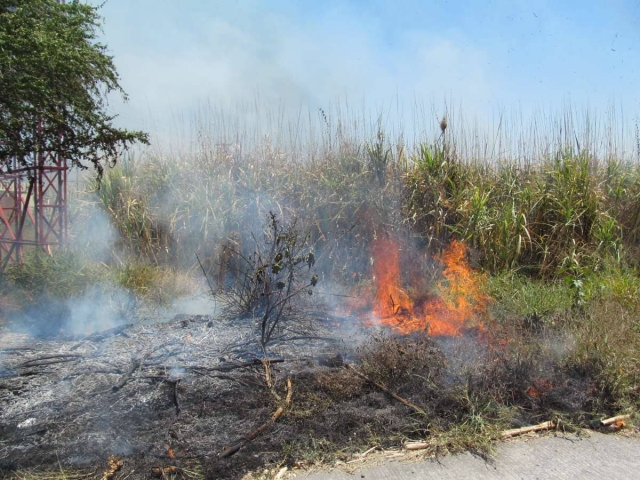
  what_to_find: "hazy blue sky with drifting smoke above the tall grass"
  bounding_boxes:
[94,0,640,142]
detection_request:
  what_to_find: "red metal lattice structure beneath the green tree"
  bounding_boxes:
[0,0,68,270]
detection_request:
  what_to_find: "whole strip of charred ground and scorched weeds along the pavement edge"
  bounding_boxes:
[0,298,632,478]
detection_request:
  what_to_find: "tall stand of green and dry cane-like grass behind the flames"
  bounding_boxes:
[69,105,640,281]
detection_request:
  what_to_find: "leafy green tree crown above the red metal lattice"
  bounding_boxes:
[0,0,148,176]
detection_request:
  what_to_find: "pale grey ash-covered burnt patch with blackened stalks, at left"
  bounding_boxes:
[0,306,378,478]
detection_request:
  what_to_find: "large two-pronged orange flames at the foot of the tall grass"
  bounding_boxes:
[364,239,486,336]
